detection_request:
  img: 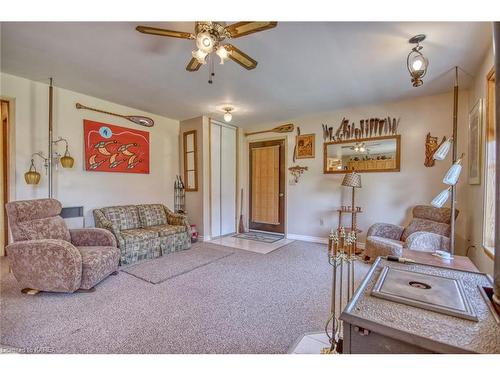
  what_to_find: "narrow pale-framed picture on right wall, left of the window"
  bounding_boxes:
[468,99,483,185]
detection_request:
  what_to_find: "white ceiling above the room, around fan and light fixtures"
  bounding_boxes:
[1,22,491,127]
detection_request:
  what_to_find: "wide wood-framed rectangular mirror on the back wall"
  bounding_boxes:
[323,135,401,173]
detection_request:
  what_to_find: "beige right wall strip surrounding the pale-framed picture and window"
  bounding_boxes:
[463,46,494,274]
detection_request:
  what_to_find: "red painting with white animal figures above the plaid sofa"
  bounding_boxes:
[83,120,149,173]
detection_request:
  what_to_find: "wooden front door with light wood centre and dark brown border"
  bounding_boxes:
[249,140,286,233]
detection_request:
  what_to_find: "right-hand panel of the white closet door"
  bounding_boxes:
[220,126,236,235]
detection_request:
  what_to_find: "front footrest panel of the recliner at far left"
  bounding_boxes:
[77,246,120,289]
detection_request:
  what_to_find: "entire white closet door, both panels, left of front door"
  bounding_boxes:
[210,120,237,238]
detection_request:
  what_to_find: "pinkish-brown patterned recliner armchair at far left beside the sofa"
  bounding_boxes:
[6,199,120,294]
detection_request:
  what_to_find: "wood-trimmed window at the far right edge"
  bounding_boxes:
[483,69,496,257]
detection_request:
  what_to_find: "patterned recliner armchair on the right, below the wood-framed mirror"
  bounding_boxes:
[365,205,458,261]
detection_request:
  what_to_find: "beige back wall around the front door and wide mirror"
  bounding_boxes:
[243,92,467,253]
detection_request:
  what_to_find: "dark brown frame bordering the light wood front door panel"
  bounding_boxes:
[248,138,287,234]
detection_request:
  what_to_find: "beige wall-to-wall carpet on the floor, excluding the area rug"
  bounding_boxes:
[0,241,368,353]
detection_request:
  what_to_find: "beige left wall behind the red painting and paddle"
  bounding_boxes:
[0,73,179,226]
